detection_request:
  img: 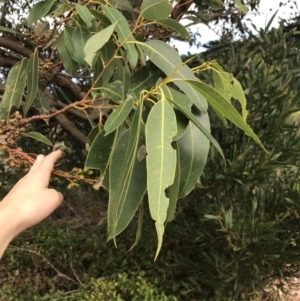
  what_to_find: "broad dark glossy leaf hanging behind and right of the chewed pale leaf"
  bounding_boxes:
[177,111,210,198]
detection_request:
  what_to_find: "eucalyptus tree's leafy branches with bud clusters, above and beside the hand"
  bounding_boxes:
[0,0,263,258]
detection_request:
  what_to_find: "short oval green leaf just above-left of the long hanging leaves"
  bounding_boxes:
[104,98,133,135]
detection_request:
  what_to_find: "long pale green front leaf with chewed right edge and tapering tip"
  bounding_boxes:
[146,97,177,258]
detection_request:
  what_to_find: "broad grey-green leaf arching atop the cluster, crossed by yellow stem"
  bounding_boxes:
[142,40,207,112]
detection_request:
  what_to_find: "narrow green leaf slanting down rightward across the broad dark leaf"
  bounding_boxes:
[162,86,225,160]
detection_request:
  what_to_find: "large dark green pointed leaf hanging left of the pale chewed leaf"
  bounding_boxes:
[108,102,147,239]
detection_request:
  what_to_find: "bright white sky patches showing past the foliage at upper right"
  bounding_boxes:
[171,0,300,55]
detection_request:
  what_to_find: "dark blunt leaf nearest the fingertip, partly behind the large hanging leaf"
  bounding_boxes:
[85,127,117,190]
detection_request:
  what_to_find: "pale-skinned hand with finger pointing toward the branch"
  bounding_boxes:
[0,151,63,258]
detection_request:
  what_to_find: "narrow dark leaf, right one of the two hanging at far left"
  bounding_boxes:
[23,48,39,116]
